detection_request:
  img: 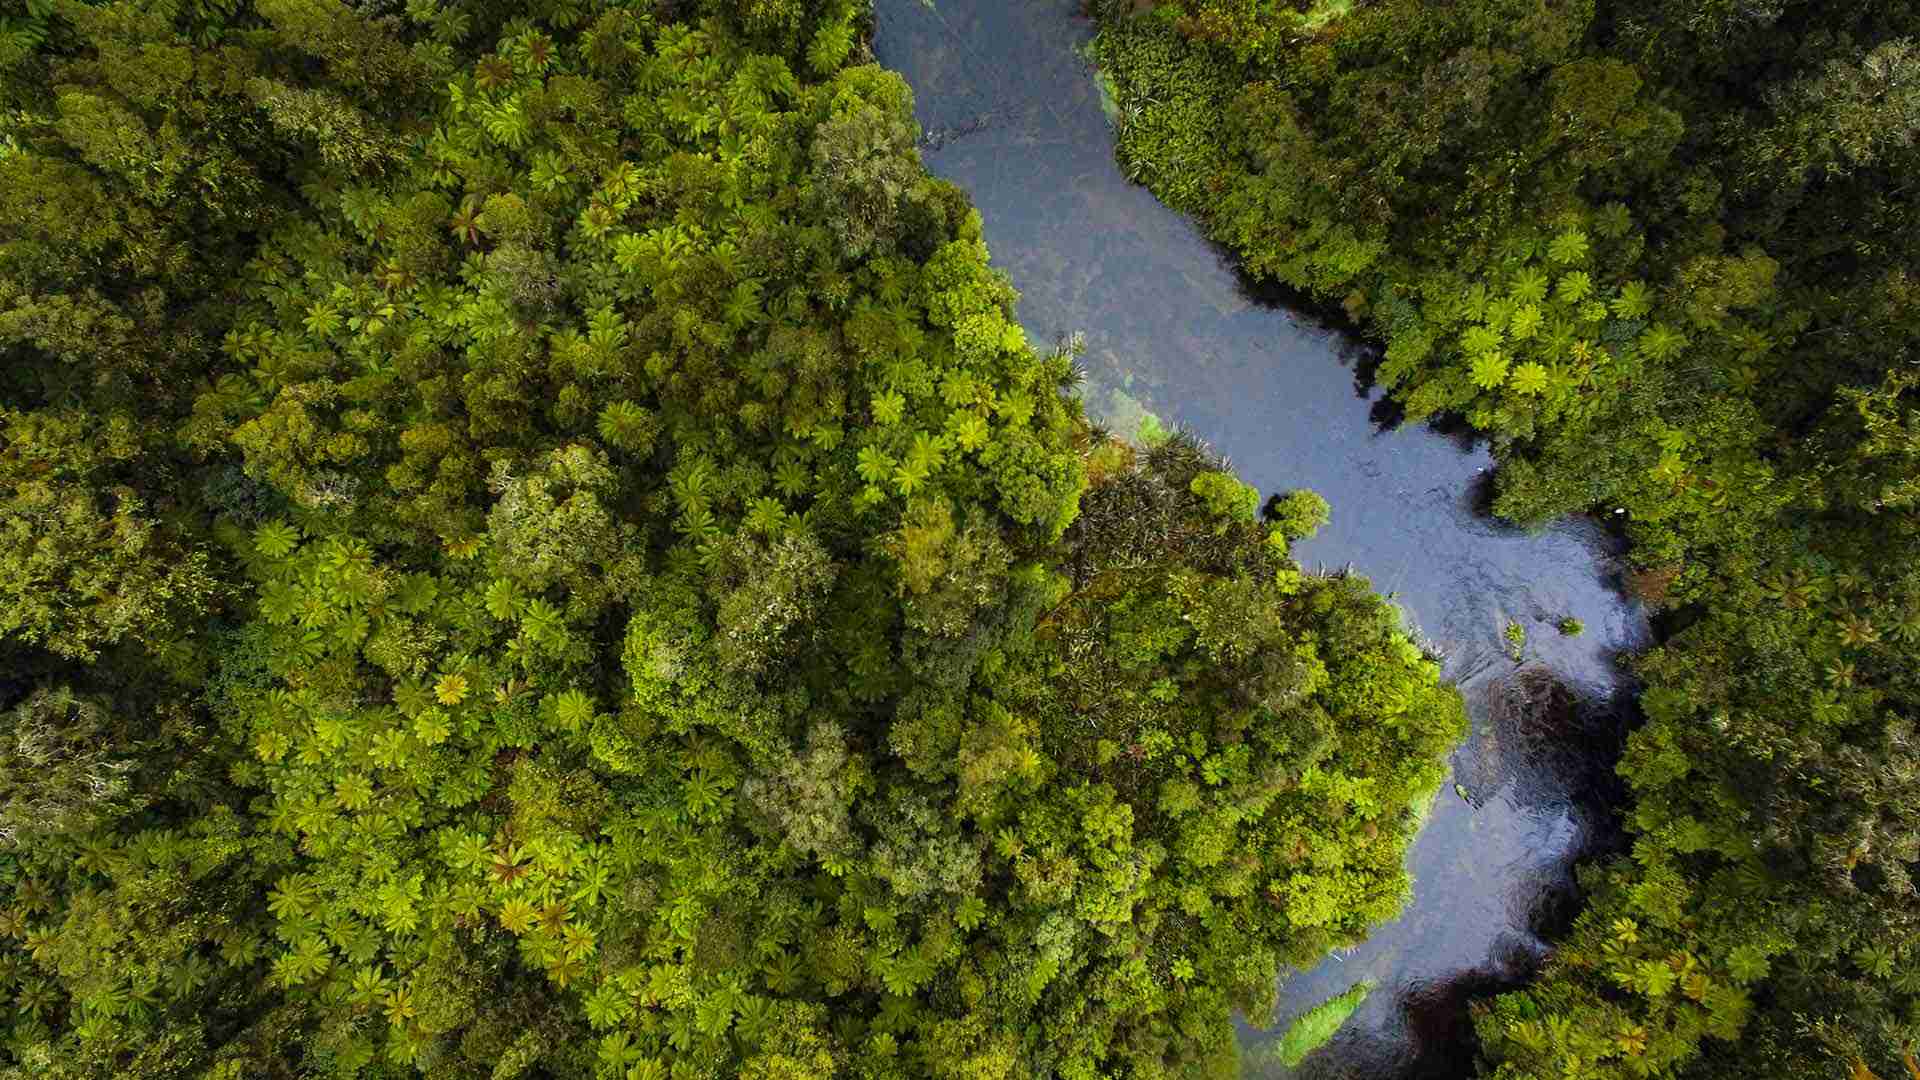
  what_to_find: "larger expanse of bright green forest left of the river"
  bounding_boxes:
[0,0,1474,1080]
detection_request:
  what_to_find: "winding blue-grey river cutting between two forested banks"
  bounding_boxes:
[876,0,1647,1076]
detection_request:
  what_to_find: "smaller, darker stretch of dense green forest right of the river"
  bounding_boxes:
[1091,0,1920,1080]
